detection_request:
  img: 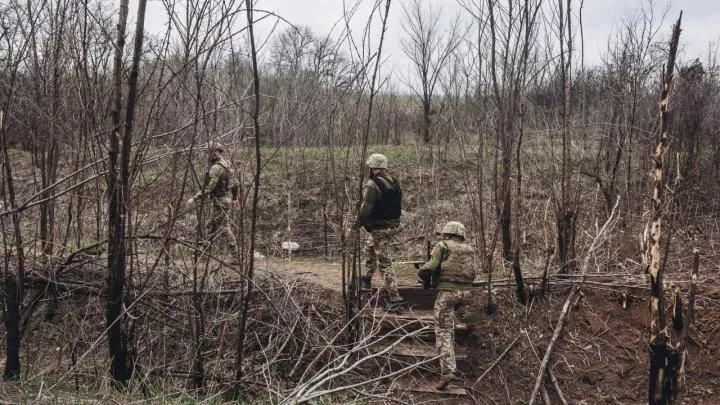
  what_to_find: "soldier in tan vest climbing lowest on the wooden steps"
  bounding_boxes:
[417,221,475,390]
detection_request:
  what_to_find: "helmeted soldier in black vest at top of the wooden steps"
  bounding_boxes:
[357,153,405,312]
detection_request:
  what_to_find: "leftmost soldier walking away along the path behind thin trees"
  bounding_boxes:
[187,142,240,259]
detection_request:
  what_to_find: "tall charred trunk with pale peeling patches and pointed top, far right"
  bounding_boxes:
[645,13,682,405]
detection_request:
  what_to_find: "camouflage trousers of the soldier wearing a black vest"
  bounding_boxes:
[364,228,402,302]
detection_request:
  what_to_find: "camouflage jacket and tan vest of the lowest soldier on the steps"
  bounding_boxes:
[417,239,475,290]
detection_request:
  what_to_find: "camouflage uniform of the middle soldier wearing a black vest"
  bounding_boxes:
[357,170,402,303]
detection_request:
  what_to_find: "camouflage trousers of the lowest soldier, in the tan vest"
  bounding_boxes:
[434,290,470,375]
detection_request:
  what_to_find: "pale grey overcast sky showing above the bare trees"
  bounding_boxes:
[142,0,720,83]
